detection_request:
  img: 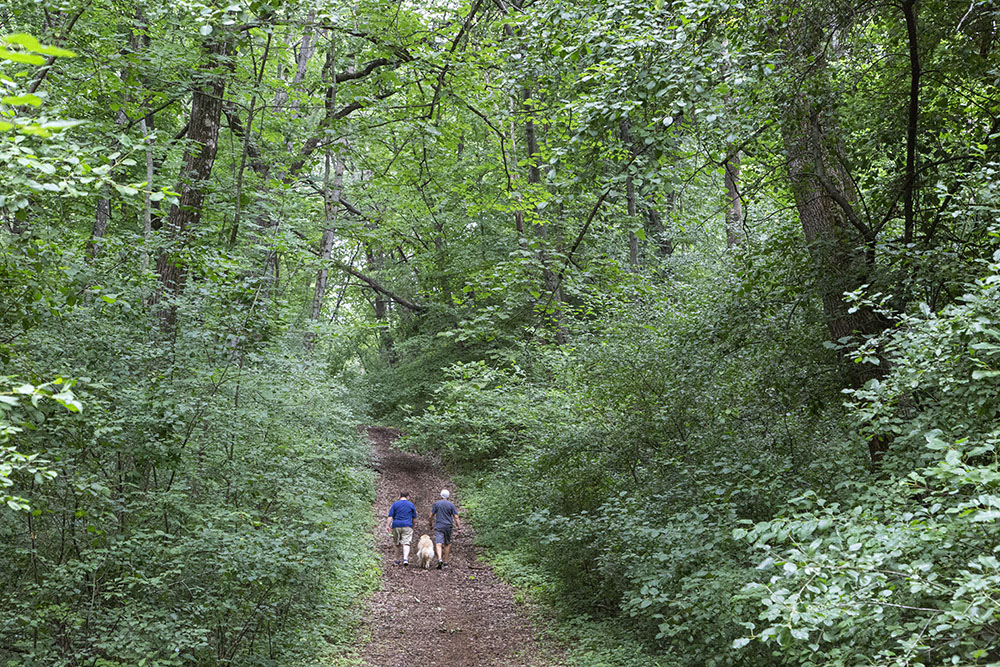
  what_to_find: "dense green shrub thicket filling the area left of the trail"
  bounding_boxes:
[0,232,374,665]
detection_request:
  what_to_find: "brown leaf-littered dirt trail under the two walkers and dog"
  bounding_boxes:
[361,427,544,667]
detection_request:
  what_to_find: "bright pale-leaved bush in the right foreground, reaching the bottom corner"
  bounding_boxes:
[738,253,1000,665]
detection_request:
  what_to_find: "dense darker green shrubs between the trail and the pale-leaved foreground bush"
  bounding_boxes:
[396,248,863,665]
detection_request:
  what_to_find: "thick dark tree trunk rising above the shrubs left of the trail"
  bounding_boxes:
[156,38,230,314]
